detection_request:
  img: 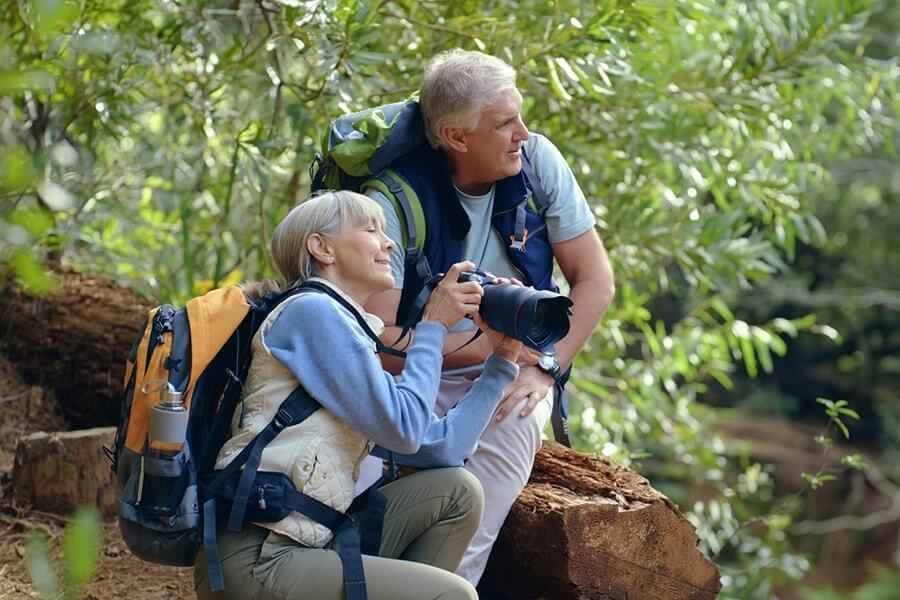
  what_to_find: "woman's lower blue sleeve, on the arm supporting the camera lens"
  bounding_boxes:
[395,356,519,467]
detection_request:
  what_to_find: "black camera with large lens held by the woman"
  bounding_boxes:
[450,269,572,352]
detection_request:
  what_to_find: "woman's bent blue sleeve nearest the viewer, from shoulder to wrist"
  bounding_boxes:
[265,294,447,453]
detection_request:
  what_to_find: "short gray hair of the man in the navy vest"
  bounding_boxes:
[419,48,517,148]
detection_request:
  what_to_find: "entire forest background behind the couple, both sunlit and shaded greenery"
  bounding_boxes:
[0,0,900,600]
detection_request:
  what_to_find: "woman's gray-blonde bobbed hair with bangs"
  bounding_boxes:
[271,190,384,284]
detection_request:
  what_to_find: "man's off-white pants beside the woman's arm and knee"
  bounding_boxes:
[435,378,553,585]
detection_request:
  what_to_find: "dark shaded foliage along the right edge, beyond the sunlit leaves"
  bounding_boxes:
[724,2,900,468]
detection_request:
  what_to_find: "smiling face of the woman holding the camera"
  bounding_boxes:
[326,221,394,304]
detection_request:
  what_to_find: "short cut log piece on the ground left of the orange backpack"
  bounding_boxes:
[12,427,119,515]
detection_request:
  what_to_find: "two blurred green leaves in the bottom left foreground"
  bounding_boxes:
[27,508,103,600]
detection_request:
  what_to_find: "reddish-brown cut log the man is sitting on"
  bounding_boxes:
[481,443,721,600]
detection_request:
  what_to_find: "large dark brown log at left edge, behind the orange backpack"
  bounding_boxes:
[0,270,150,428]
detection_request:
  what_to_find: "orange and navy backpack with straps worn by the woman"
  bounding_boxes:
[105,282,402,600]
